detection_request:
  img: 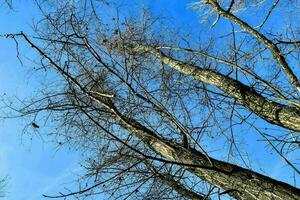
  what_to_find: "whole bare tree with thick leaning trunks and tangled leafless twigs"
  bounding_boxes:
[2,0,300,199]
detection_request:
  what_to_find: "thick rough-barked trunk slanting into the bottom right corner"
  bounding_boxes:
[106,105,300,200]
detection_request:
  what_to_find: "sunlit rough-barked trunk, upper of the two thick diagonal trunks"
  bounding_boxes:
[133,45,300,131]
